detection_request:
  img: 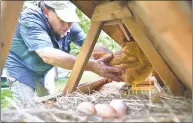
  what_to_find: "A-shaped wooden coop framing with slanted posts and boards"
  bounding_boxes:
[0,0,192,101]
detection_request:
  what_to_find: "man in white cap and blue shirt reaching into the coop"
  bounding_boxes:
[5,1,123,107]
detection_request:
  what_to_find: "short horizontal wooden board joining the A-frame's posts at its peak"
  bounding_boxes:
[91,1,132,21]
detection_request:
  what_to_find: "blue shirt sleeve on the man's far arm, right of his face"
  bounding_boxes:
[70,23,86,46]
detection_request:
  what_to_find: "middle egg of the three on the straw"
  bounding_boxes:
[95,104,117,118]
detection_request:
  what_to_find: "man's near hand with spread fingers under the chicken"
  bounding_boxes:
[92,54,124,82]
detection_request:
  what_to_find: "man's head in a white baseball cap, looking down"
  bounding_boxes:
[40,1,80,35]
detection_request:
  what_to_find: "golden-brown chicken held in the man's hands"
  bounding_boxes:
[92,41,153,84]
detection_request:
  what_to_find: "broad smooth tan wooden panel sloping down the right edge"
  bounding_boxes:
[128,1,192,91]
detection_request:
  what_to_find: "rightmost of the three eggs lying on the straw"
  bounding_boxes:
[109,99,127,117]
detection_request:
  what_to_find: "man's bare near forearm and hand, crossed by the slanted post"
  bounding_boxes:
[36,47,123,81]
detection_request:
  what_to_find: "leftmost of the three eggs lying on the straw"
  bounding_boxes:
[77,102,96,116]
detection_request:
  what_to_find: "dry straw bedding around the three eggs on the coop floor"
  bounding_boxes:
[1,82,192,122]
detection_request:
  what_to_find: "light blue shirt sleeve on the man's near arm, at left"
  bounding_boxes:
[20,23,53,51]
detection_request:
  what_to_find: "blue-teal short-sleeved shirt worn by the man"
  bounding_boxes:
[5,7,86,88]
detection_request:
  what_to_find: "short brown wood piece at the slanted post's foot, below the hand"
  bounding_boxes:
[77,78,109,94]
